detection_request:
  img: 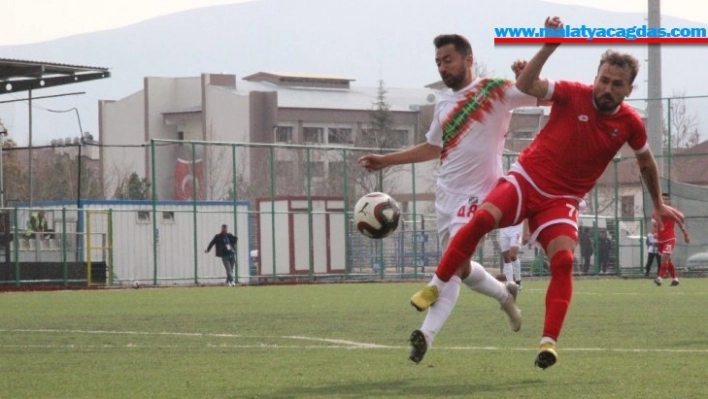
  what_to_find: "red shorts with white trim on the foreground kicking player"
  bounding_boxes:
[484,172,579,249]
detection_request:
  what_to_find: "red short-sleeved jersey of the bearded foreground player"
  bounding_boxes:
[519,81,649,198]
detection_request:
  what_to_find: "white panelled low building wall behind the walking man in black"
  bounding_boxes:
[85,201,250,285]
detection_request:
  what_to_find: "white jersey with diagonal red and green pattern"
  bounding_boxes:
[425,79,536,197]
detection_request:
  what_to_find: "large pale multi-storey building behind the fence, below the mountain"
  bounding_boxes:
[99,72,438,205]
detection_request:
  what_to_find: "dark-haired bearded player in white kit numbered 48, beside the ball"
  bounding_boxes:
[358,35,536,363]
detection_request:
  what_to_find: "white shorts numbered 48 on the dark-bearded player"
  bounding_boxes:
[435,187,487,250]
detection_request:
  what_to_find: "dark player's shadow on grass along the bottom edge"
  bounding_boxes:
[269,379,543,398]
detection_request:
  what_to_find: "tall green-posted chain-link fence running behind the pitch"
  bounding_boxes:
[0,94,708,285]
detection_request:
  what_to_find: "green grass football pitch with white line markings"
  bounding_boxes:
[0,278,708,399]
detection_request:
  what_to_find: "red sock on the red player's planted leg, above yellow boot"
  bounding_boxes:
[543,250,573,340]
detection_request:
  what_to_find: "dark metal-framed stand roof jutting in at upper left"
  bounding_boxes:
[0,58,111,94]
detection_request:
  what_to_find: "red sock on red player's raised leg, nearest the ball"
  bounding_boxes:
[435,209,496,281]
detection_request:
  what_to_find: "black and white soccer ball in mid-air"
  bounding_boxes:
[354,192,401,238]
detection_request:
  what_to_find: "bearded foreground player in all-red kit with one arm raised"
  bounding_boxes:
[412,17,682,369]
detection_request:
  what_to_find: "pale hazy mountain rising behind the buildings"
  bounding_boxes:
[0,0,708,145]
